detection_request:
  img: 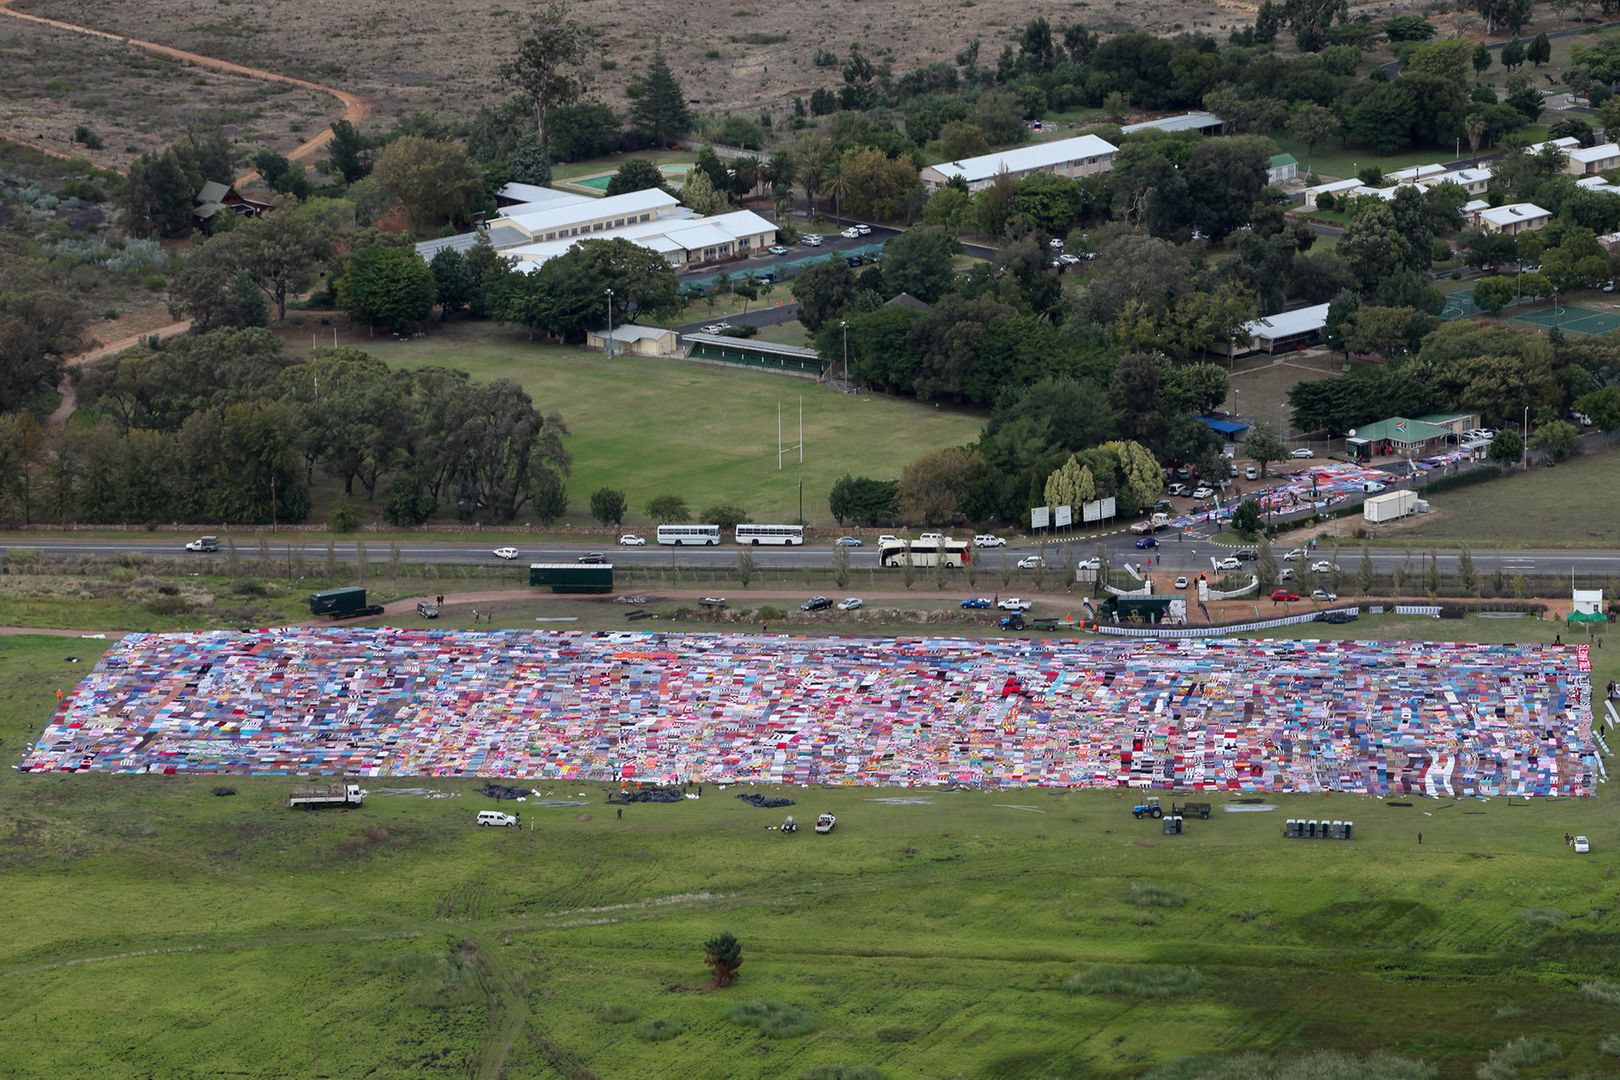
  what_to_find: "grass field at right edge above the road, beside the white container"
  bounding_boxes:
[1390,450,1620,547]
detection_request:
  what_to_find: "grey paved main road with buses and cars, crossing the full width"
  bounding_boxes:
[0,533,1620,575]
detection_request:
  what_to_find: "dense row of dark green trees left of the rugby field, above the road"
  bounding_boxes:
[0,329,569,525]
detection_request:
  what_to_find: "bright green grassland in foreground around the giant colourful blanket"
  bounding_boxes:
[0,619,1620,1080]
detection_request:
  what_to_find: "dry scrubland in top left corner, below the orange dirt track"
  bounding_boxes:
[0,18,337,170]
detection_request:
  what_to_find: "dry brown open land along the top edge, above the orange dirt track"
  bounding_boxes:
[19,0,1254,120]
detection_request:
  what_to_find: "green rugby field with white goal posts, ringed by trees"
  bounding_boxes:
[335,324,983,525]
